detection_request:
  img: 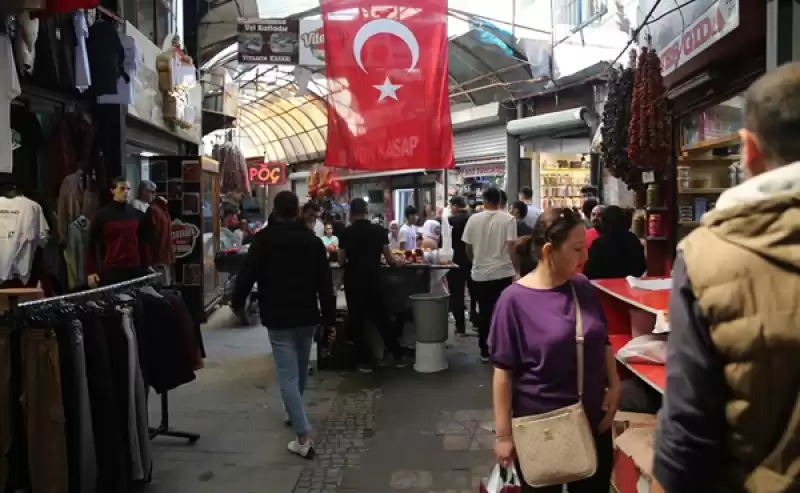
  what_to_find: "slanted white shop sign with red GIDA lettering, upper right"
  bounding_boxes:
[659,0,739,75]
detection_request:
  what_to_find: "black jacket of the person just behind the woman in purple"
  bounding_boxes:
[583,231,647,279]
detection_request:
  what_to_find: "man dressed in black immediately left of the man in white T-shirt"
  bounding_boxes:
[447,197,477,335]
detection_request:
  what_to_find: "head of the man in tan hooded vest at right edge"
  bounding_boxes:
[744,63,800,166]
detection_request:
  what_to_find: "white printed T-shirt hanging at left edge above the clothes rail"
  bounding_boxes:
[0,195,50,283]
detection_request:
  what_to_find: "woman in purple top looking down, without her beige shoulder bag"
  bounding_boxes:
[489,209,620,493]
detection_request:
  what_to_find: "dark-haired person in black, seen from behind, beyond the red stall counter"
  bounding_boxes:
[583,205,647,279]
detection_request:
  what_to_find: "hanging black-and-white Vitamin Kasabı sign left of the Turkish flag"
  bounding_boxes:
[238,19,325,67]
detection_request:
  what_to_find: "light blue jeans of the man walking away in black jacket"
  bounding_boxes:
[267,326,317,435]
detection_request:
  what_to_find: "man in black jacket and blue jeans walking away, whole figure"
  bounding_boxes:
[231,191,336,459]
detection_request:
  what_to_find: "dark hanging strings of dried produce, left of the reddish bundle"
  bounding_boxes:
[600,51,641,188]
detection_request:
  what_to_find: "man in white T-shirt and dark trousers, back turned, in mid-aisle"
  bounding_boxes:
[461,188,517,363]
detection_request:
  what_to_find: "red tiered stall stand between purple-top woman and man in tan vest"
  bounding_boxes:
[592,279,669,493]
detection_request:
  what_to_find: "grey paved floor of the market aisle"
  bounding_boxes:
[146,308,494,493]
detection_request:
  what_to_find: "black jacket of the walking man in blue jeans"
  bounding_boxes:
[232,221,336,329]
